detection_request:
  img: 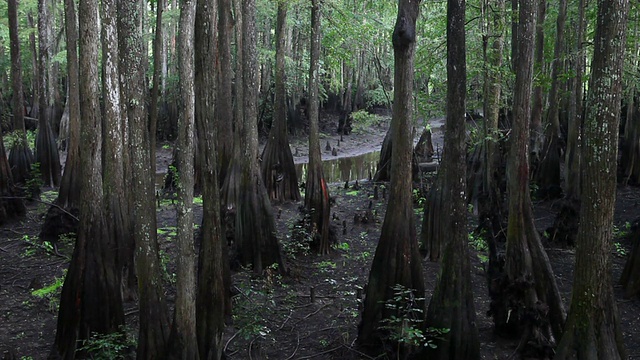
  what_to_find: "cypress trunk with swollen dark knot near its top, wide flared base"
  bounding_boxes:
[358,0,425,352]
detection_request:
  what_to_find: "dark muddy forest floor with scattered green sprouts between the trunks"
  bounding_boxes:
[0,112,640,360]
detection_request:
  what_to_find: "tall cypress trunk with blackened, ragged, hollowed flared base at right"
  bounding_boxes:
[490,0,565,351]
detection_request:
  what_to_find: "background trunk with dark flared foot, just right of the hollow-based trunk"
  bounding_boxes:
[536,0,567,197]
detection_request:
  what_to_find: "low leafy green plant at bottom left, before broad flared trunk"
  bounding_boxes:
[78,327,137,360]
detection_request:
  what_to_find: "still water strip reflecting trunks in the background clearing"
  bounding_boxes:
[296,151,380,183]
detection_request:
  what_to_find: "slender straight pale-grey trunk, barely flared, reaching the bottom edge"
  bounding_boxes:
[168,0,200,360]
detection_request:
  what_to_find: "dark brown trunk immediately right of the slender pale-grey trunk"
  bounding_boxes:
[194,0,231,359]
